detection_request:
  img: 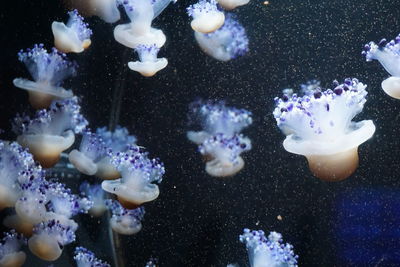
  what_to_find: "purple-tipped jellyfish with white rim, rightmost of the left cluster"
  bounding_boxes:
[101,146,165,209]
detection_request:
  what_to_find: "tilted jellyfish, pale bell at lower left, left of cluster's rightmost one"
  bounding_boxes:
[68,129,109,178]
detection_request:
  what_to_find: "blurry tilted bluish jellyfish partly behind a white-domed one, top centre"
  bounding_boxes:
[194,14,249,61]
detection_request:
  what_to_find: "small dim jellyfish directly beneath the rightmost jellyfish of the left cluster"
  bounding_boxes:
[106,199,145,235]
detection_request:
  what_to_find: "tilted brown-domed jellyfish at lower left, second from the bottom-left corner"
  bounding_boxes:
[28,220,75,261]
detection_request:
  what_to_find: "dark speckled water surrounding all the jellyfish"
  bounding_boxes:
[0,0,400,266]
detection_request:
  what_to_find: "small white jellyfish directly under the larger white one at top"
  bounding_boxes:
[128,44,168,77]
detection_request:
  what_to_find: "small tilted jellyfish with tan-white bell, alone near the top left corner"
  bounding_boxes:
[51,9,92,53]
